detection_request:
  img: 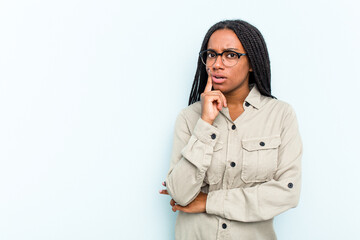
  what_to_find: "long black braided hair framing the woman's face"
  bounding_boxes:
[188,20,277,105]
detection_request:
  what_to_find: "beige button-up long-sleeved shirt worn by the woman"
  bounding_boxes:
[166,84,303,240]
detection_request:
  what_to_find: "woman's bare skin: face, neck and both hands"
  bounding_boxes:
[159,29,253,213]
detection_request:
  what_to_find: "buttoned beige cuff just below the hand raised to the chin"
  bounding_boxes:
[194,117,220,147]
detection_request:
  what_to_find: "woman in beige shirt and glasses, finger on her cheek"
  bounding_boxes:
[160,20,303,240]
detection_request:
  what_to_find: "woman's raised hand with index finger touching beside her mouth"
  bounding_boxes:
[200,69,227,125]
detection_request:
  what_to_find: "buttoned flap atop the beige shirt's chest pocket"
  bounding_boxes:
[241,135,281,151]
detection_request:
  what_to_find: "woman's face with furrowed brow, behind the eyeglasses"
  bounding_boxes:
[207,29,252,94]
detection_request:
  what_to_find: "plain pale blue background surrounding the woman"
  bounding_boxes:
[0,0,360,240]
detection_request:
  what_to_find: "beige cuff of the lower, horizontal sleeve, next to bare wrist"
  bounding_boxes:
[205,190,226,218]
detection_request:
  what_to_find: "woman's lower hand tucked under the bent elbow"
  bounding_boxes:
[160,182,207,213]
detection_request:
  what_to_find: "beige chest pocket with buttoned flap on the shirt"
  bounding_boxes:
[241,136,281,183]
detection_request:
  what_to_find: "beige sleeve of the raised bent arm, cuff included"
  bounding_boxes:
[166,111,220,206]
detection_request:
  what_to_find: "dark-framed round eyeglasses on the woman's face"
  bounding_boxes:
[199,49,246,67]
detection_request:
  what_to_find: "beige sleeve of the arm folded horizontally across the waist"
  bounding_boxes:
[206,105,303,222]
